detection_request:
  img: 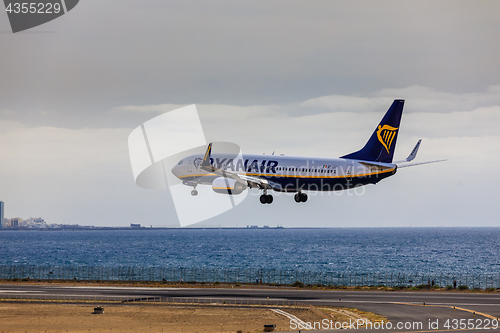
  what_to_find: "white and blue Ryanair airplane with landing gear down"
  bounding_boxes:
[171,99,445,204]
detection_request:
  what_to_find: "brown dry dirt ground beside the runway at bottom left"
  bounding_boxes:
[0,302,304,333]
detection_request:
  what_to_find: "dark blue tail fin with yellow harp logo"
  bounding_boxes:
[341,99,405,163]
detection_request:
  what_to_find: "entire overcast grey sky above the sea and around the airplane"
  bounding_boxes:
[0,0,500,227]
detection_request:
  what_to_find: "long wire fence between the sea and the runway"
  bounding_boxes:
[0,265,500,289]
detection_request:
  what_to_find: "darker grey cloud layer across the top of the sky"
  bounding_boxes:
[0,0,500,120]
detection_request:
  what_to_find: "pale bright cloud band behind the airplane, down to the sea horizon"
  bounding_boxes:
[0,86,500,226]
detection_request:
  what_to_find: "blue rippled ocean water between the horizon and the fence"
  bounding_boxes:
[0,228,500,274]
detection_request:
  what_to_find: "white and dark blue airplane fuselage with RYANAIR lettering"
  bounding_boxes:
[172,154,397,192]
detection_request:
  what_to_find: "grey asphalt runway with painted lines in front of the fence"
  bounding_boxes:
[0,285,500,332]
